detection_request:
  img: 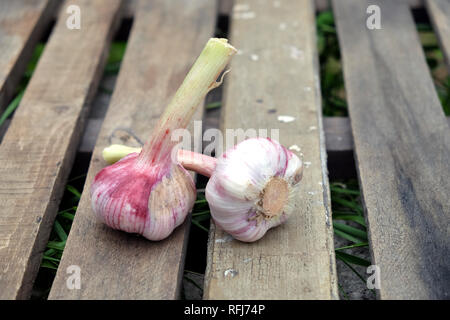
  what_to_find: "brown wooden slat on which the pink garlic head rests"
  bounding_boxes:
[49,0,216,299]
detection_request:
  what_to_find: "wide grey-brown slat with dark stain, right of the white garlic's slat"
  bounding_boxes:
[333,0,450,299]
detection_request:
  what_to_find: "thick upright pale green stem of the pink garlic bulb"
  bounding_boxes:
[138,38,236,168]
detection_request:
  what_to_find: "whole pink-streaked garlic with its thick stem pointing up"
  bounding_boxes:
[90,39,236,240]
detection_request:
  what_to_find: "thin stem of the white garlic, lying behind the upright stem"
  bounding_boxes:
[102,144,217,178]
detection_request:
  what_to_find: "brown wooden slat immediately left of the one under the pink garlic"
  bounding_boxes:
[0,0,120,299]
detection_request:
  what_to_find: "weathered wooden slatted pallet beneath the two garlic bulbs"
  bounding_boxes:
[0,0,450,299]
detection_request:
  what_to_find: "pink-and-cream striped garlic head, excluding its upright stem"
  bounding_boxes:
[90,153,196,240]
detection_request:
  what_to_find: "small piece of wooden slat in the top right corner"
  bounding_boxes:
[425,0,450,70]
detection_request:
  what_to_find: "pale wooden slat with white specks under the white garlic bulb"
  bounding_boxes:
[204,0,338,300]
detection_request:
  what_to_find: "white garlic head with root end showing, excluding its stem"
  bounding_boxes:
[206,138,303,242]
